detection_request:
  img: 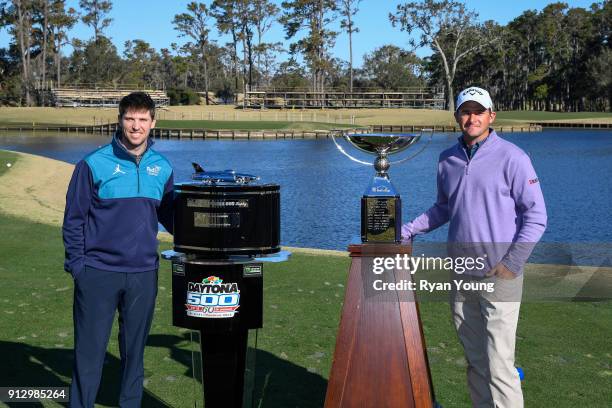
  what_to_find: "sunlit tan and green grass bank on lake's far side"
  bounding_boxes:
[0,106,612,130]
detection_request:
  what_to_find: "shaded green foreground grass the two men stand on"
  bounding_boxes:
[0,190,612,408]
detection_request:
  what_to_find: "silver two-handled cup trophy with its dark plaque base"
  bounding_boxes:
[332,129,433,243]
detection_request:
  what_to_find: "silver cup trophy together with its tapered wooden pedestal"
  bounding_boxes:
[324,130,435,408]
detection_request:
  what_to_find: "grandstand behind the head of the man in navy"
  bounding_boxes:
[48,85,170,108]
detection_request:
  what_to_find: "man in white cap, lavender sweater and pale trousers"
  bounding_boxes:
[402,87,546,408]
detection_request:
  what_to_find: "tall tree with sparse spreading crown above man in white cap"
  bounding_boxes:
[389,0,498,111]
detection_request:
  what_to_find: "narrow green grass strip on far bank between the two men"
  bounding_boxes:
[157,120,351,130]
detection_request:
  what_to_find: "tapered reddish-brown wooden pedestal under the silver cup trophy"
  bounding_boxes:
[325,243,434,408]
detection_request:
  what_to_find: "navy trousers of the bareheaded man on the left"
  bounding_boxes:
[70,267,157,408]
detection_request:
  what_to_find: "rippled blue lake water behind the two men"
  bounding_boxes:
[0,130,612,262]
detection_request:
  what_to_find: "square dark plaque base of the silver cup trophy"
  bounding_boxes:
[361,195,402,244]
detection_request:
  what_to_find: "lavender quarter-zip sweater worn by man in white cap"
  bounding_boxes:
[402,130,546,274]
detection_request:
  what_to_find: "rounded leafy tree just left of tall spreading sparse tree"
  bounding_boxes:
[363,45,423,90]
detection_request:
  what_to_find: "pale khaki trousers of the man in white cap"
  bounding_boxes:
[451,276,523,408]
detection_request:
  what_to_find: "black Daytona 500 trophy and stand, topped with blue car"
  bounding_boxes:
[163,165,280,408]
